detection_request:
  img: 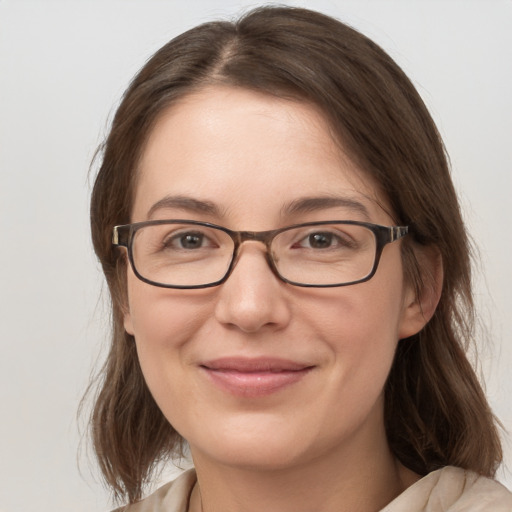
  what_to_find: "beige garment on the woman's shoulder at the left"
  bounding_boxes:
[112,469,196,512]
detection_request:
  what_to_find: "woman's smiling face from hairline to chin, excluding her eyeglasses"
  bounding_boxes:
[125,86,417,468]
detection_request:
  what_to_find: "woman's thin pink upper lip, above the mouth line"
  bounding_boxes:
[200,357,314,373]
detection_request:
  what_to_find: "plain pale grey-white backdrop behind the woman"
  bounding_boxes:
[0,0,512,512]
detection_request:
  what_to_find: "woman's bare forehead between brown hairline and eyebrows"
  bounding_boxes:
[132,86,392,229]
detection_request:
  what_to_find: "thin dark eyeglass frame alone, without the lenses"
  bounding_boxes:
[112,219,409,290]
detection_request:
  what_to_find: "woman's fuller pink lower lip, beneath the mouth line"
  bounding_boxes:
[202,367,312,398]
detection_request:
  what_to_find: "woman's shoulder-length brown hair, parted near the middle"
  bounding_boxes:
[91,7,502,502]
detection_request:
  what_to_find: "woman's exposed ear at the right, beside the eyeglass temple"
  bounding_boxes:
[398,246,444,339]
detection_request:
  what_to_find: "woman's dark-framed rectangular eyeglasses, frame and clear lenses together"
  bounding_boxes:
[112,220,408,289]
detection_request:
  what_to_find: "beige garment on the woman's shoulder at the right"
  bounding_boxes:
[382,466,512,512]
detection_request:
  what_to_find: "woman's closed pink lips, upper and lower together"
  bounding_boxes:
[200,357,314,398]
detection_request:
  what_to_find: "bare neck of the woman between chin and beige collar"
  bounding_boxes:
[189,428,417,512]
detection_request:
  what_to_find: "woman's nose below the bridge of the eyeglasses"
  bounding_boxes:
[215,242,291,333]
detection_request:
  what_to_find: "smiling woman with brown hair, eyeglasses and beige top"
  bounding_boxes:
[91,7,512,512]
